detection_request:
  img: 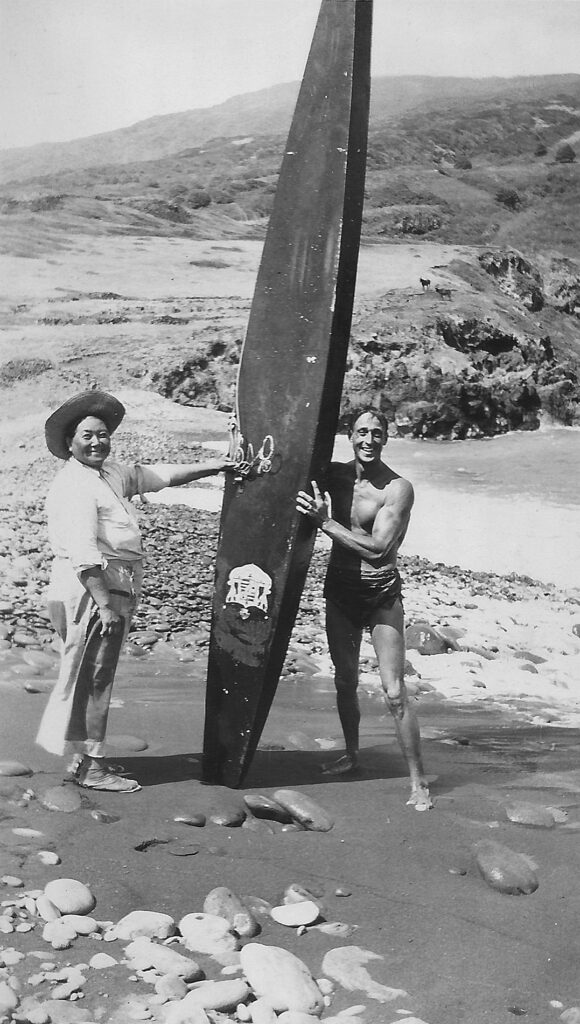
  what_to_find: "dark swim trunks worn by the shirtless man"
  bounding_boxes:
[324,565,402,629]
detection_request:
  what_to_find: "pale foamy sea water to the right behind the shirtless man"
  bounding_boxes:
[334,427,580,589]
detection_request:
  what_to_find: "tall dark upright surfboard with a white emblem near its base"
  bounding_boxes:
[203,0,372,787]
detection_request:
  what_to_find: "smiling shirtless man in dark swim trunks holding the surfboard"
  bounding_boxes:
[296,410,432,811]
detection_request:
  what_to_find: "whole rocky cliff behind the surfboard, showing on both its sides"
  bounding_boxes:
[152,249,580,438]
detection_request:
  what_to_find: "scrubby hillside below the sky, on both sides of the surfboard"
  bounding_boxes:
[0,76,580,258]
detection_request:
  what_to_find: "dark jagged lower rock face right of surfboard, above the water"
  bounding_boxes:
[342,315,580,438]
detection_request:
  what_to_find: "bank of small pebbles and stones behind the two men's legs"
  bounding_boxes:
[0,493,580,714]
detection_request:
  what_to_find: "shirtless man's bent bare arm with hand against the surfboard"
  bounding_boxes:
[296,479,414,563]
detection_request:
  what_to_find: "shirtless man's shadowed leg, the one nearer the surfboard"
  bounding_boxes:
[323,601,362,775]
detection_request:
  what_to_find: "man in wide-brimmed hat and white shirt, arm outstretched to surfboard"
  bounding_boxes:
[37,390,234,793]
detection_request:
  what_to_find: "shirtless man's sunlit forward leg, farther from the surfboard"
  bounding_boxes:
[371,600,433,811]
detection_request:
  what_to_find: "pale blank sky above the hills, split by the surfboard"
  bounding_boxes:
[0,0,580,147]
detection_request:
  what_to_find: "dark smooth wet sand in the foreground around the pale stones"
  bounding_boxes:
[0,565,580,1024]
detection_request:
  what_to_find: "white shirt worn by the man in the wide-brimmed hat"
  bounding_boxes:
[46,459,171,572]
